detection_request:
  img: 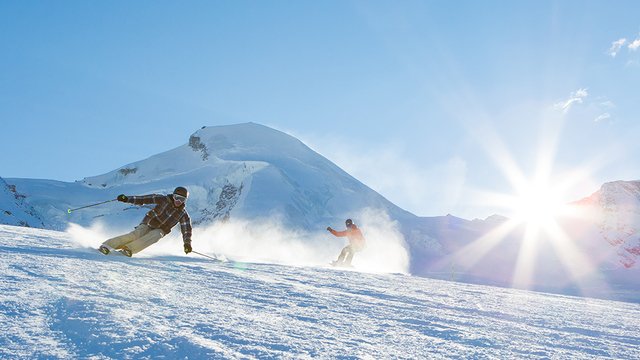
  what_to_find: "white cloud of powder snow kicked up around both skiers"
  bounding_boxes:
[67,208,409,273]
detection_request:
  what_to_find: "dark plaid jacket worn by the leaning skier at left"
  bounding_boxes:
[127,194,191,244]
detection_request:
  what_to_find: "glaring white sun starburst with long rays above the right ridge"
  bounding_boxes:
[451,114,606,293]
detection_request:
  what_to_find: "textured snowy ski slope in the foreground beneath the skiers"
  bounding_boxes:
[0,226,640,359]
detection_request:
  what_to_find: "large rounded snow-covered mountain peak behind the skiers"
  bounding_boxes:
[6,123,413,230]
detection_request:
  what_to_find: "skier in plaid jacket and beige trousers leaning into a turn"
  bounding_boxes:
[98,186,191,257]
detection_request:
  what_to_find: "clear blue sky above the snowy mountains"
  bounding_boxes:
[0,1,640,218]
